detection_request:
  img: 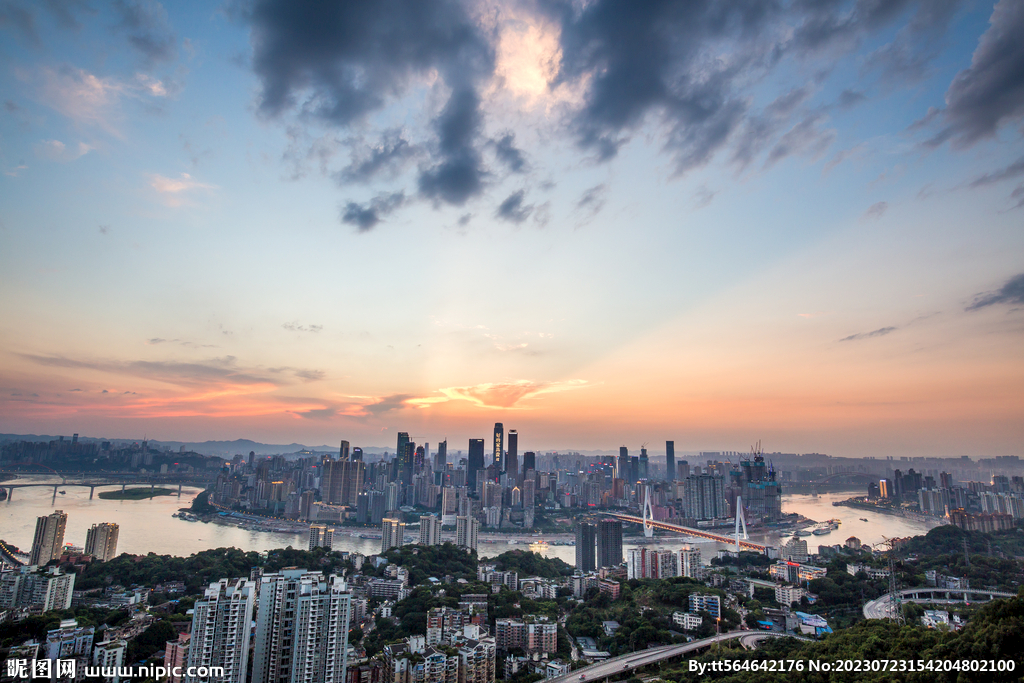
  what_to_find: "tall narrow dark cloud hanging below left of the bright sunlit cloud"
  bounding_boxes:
[419,89,486,206]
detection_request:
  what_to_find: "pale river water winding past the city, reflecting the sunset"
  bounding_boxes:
[0,476,939,564]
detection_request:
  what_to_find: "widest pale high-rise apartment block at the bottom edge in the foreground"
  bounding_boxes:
[252,569,352,683]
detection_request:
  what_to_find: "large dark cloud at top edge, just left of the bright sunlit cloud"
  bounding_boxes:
[247,0,493,125]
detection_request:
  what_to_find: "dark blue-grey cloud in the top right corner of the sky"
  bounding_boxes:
[930,0,1024,147]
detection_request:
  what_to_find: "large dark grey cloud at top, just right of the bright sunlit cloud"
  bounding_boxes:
[550,0,778,172]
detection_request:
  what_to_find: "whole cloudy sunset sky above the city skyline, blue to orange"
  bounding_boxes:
[0,0,1024,458]
